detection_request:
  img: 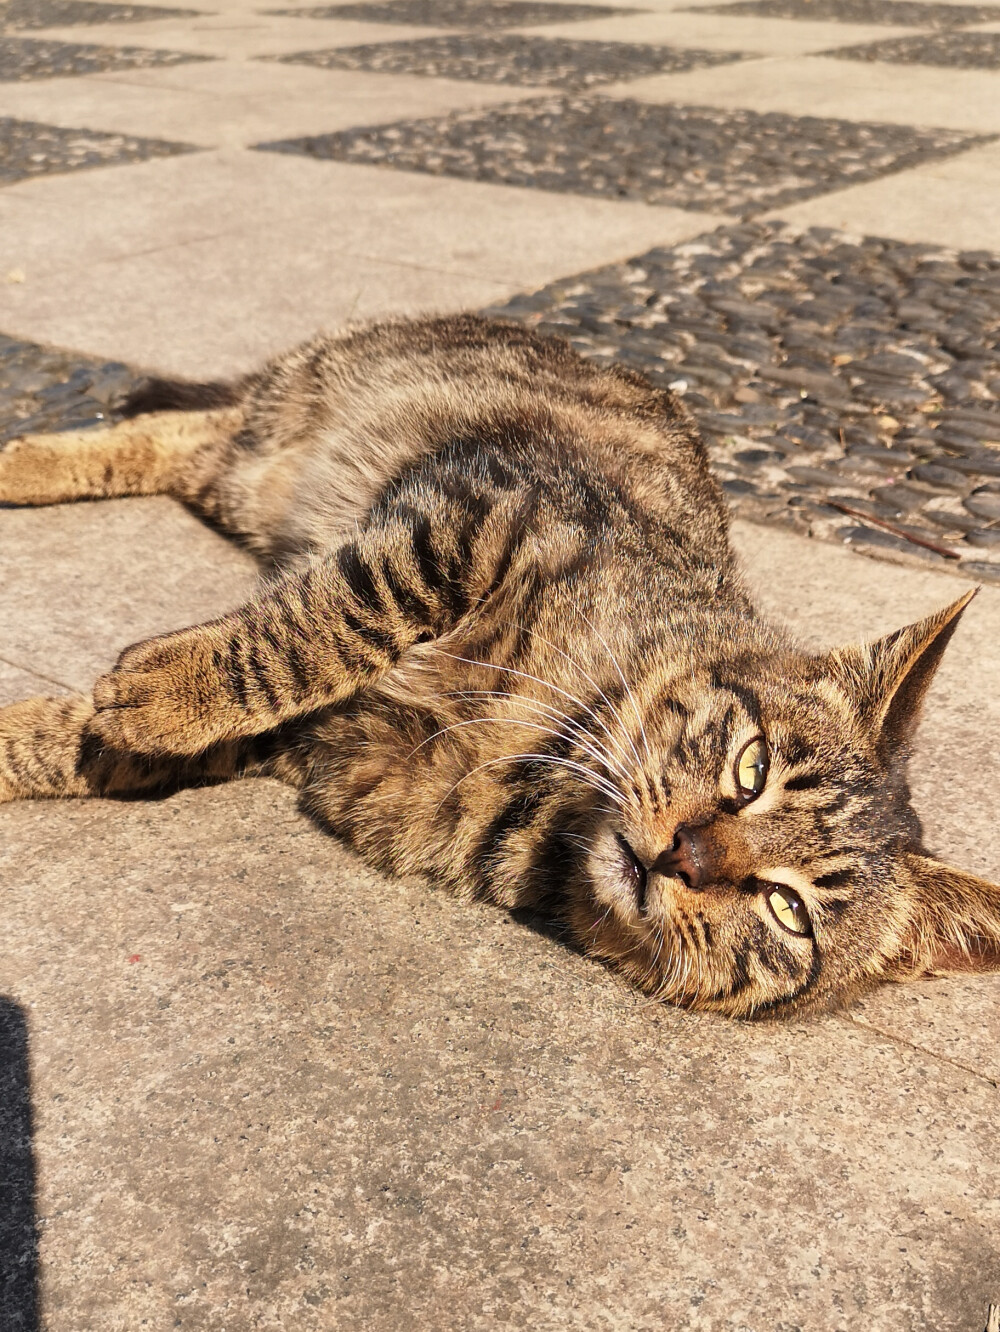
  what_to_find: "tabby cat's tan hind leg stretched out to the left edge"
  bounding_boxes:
[0,408,242,505]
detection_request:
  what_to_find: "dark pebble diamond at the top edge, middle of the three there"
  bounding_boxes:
[264,0,644,24]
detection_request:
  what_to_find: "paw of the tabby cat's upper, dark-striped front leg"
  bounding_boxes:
[89,629,238,755]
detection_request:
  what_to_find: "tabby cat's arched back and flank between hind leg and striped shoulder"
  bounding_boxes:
[230,314,727,558]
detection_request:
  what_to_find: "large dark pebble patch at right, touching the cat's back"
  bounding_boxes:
[474,221,1000,581]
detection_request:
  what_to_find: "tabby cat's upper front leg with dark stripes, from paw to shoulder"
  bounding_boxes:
[92,494,529,755]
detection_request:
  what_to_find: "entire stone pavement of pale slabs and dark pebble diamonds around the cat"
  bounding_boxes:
[0,0,1000,1332]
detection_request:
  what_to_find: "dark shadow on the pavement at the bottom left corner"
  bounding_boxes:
[0,995,40,1332]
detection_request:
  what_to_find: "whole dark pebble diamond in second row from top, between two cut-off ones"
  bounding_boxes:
[267,33,742,92]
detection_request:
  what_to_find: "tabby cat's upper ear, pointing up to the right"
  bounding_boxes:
[827,587,979,763]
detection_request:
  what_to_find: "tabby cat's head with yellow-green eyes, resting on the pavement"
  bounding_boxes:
[573,593,1000,1015]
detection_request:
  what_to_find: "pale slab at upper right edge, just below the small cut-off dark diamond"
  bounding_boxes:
[609,56,1000,135]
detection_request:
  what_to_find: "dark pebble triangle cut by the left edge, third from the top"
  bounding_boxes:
[0,116,197,185]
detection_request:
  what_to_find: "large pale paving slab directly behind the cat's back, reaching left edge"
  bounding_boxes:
[0,152,718,374]
